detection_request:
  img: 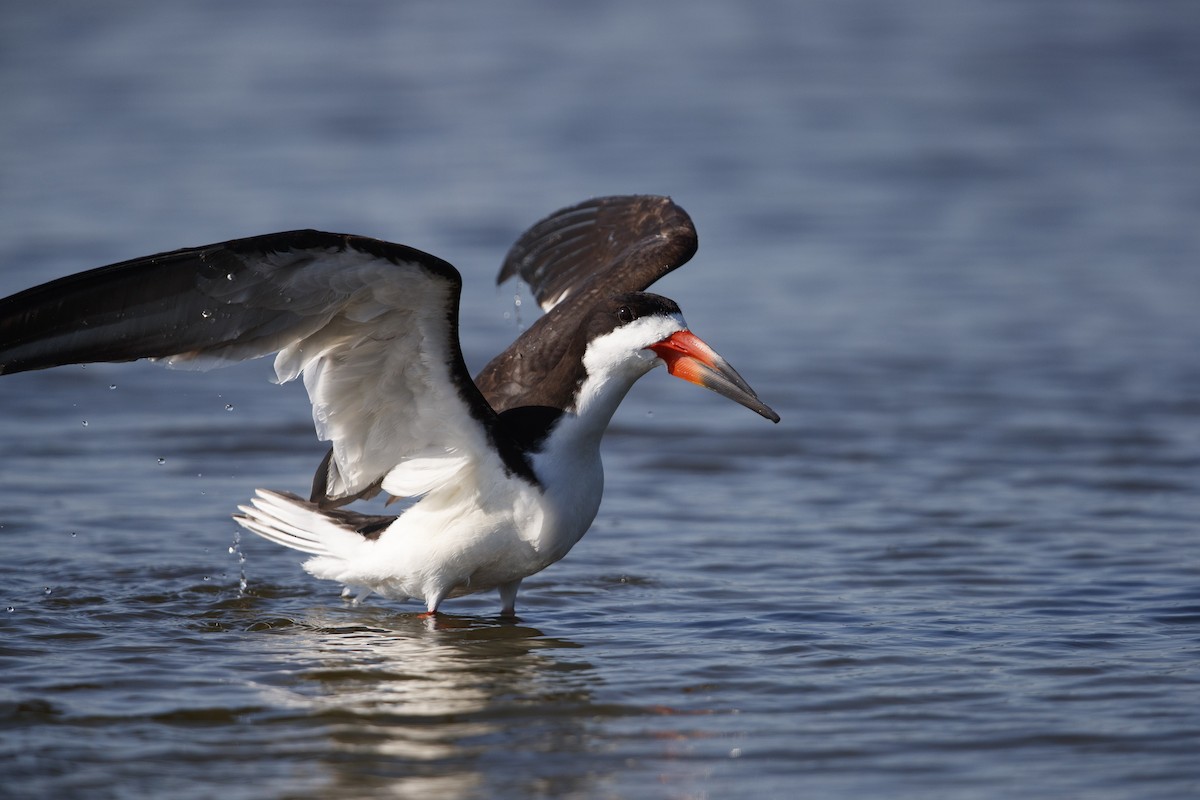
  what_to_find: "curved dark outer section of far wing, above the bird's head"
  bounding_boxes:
[497,194,697,311]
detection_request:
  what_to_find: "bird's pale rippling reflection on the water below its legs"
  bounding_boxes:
[254,608,609,799]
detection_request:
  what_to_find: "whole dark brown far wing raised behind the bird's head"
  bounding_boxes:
[475,194,697,414]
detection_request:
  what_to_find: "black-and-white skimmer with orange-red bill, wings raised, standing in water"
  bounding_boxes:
[0,194,779,618]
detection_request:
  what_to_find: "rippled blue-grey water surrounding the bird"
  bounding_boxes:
[0,0,1200,798]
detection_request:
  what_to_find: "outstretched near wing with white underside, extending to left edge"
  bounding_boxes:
[0,230,521,501]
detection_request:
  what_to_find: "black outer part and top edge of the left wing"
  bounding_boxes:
[0,230,451,374]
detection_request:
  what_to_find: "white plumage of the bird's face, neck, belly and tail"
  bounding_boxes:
[235,314,686,614]
